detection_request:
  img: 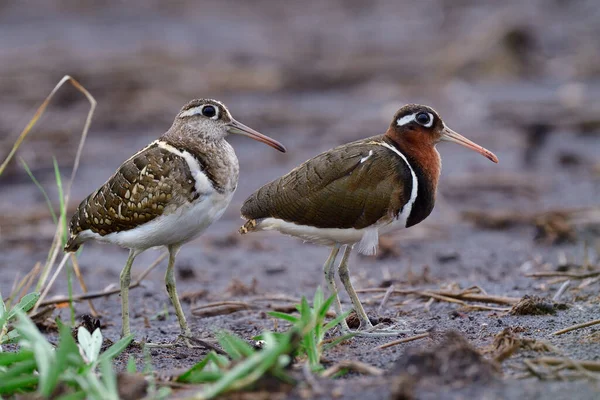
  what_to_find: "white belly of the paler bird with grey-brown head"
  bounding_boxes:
[96,192,233,250]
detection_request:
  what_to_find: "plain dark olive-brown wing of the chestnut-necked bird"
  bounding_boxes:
[242,136,412,229]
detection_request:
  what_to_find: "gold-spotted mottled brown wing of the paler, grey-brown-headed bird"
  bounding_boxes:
[66,143,198,249]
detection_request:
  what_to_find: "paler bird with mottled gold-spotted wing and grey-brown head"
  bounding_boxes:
[64,99,286,345]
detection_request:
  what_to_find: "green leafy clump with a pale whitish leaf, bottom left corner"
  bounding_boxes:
[0,310,133,400]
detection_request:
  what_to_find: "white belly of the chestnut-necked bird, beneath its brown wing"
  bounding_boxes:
[256,218,366,246]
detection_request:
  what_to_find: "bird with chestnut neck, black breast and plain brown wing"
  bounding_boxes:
[240,104,498,336]
